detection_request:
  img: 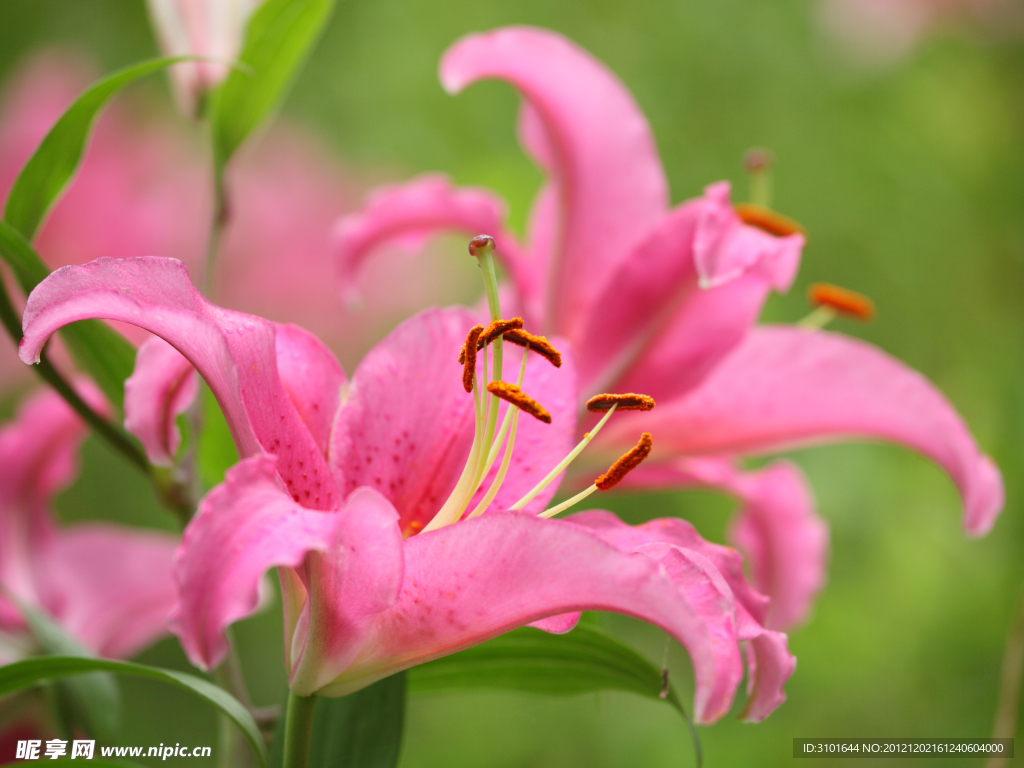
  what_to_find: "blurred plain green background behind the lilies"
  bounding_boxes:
[0,0,1024,768]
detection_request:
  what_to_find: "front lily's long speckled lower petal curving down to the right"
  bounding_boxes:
[321,513,770,723]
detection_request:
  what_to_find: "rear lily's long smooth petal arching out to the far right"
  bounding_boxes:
[598,326,1004,536]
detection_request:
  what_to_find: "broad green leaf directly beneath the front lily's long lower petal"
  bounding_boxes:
[409,624,701,768]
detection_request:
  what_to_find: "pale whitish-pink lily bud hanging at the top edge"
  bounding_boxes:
[147,0,263,116]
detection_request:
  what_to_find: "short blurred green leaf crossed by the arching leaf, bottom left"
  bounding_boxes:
[18,603,121,743]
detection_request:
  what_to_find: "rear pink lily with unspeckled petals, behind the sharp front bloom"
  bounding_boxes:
[336,27,1002,629]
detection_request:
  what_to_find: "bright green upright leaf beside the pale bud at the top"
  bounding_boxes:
[210,0,334,173]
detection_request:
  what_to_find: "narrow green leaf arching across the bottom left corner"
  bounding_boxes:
[0,656,266,768]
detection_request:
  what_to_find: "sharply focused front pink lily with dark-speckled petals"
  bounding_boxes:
[20,256,795,723]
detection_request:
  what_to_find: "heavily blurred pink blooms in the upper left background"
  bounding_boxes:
[0,52,454,391]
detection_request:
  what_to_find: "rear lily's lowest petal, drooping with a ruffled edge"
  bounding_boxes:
[623,458,828,630]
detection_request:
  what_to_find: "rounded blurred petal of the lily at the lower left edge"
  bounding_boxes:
[37,523,177,658]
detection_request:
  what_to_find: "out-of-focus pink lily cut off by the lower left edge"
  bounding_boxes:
[0,387,177,664]
